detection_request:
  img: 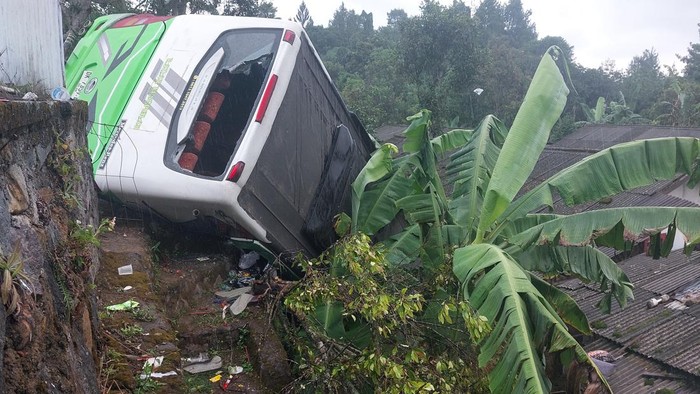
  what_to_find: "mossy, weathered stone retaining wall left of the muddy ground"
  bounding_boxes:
[0,100,100,393]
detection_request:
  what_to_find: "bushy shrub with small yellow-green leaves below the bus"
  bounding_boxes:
[285,233,488,393]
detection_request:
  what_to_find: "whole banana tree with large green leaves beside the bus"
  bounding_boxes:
[352,47,700,393]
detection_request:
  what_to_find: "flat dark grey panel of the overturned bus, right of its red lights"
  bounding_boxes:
[238,37,369,255]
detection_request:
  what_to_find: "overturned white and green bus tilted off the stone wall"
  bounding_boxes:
[66,14,375,255]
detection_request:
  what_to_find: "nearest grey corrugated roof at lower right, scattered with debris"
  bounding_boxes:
[558,251,700,392]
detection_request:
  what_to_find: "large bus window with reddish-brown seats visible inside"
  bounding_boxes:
[166,29,282,177]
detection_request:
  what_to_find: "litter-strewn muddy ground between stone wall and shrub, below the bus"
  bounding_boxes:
[96,223,291,393]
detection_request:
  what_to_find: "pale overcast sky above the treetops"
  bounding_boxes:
[272,0,700,69]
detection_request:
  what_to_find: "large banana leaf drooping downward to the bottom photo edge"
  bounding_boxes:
[453,244,580,393]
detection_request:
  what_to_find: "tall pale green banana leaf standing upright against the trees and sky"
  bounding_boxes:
[475,47,569,242]
